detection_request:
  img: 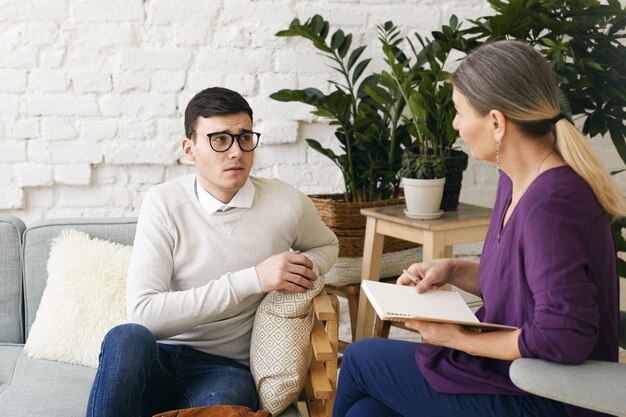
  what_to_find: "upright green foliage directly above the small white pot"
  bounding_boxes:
[378,15,468,179]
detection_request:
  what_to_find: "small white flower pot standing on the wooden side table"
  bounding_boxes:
[402,178,446,219]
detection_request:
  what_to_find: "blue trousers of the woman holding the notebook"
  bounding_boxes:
[333,339,567,417]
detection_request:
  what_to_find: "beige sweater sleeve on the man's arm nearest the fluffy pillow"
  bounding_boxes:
[126,190,261,339]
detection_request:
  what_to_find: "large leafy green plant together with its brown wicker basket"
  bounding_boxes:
[270,15,419,284]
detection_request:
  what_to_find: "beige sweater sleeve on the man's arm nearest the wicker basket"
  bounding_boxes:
[293,191,339,275]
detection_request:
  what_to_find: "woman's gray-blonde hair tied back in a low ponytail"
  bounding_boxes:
[451,40,626,220]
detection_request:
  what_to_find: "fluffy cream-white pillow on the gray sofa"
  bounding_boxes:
[25,230,132,368]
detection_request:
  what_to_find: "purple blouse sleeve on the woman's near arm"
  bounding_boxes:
[518,200,599,364]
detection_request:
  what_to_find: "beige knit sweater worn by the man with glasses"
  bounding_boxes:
[127,175,339,363]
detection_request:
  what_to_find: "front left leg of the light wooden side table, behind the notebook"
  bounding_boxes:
[355,217,385,340]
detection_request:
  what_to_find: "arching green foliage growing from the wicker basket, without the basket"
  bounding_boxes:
[270,15,411,201]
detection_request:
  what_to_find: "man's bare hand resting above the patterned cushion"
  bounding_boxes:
[254,251,317,292]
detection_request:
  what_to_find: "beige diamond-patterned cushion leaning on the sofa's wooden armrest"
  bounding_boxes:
[250,277,324,415]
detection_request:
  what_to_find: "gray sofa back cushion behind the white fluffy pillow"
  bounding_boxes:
[23,218,137,337]
